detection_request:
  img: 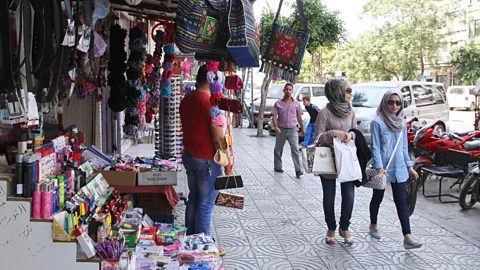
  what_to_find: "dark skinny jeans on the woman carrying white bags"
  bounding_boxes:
[320,176,355,231]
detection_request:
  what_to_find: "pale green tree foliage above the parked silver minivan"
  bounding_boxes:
[335,0,448,80]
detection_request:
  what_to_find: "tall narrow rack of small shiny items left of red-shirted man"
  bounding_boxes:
[155,76,183,163]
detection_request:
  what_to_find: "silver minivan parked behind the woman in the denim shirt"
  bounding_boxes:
[352,81,449,144]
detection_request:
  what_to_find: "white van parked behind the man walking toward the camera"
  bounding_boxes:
[253,83,328,126]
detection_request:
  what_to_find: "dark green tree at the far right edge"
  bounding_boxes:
[452,45,480,84]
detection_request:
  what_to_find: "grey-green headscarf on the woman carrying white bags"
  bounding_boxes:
[325,79,352,118]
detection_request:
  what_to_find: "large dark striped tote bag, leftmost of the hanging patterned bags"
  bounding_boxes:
[175,0,229,54]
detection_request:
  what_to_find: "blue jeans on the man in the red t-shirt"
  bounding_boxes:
[183,150,223,235]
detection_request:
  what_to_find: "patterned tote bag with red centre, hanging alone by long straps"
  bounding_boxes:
[260,0,310,83]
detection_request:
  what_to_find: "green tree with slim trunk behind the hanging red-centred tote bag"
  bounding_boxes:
[257,0,344,137]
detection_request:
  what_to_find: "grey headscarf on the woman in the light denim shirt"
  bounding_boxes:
[377,89,405,132]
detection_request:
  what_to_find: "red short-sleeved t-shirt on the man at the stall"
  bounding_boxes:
[180,90,215,160]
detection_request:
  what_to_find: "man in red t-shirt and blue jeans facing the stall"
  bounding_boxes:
[180,65,224,235]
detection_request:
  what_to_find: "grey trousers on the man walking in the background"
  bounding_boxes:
[273,127,302,172]
